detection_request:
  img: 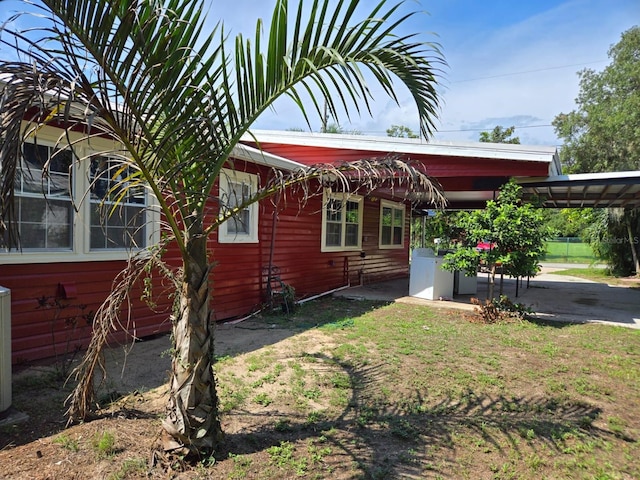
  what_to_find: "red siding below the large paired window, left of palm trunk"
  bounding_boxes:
[0,261,171,363]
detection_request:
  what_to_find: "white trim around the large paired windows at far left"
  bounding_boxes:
[0,127,160,265]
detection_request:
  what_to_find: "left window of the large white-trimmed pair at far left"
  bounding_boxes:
[13,143,73,251]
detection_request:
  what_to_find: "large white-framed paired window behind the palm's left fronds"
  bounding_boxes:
[0,133,160,264]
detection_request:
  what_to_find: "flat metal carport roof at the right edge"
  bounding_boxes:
[518,171,640,208]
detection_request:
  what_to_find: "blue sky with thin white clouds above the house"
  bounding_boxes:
[0,0,640,145]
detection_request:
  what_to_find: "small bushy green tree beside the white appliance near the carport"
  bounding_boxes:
[444,181,551,299]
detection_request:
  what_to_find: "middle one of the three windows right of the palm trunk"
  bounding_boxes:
[322,194,362,252]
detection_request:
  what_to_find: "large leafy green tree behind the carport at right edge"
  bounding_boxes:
[553,26,640,275]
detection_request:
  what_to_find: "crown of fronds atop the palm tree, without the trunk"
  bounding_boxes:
[0,0,445,248]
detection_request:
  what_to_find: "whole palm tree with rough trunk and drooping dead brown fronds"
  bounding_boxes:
[0,0,444,454]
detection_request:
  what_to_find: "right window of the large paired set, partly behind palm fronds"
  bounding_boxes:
[89,155,148,251]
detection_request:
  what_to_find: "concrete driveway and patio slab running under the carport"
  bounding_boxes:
[334,266,640,329]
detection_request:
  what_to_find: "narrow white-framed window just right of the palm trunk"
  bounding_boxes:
[218,169,258,243]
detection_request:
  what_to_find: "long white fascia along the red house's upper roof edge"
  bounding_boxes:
[242,130,559,165]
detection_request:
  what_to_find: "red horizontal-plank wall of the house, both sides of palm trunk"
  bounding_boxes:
[0,163,409,363]
